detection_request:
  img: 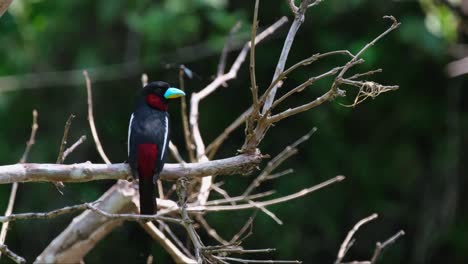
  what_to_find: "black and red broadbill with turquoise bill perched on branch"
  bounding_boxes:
[128,82,185,214]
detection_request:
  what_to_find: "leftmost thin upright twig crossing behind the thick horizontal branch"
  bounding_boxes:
[0,109,39,258]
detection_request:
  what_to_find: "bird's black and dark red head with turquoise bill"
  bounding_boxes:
[142,81,185,111]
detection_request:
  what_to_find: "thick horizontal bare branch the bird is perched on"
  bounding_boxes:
[0,153,263,184]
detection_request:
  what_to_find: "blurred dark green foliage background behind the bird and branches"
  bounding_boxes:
[0,0,468,263]
